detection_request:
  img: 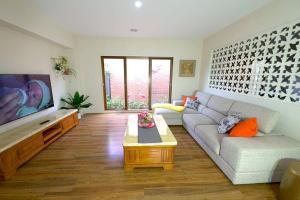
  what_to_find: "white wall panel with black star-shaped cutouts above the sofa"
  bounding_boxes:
[209,23,300,102]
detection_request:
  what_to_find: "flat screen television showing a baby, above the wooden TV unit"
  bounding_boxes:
[0,74,54,125]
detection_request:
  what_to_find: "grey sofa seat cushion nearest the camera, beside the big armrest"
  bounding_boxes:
[195,125,228,155]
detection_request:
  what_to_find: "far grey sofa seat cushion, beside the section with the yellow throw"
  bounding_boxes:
[183,114,216,130]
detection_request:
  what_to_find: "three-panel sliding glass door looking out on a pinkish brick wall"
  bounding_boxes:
[101,56,173,110]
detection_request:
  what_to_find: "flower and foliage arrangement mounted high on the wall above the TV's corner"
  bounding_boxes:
[52,56,76,76]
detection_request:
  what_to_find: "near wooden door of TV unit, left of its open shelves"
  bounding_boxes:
[17,133,44,166]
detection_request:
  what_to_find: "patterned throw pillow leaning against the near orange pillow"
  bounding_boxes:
[218,112,241,134]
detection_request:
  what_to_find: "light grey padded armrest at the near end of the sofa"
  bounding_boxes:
[220,134,300,173]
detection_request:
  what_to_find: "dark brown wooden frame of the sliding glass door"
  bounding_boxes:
[101,56,173,111]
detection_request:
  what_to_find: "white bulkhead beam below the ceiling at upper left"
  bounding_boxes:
[0,0,74,48]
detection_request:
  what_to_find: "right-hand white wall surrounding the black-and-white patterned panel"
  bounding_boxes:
[200,0,300,140]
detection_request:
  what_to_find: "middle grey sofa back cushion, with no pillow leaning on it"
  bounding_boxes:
[207,95,234,115]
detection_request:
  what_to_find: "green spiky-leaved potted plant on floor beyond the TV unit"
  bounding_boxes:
[61,91,93,119]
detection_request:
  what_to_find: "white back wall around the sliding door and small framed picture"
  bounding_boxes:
[71,37,202,113]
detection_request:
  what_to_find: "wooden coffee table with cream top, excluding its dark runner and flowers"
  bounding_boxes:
[123,114,177,171]
